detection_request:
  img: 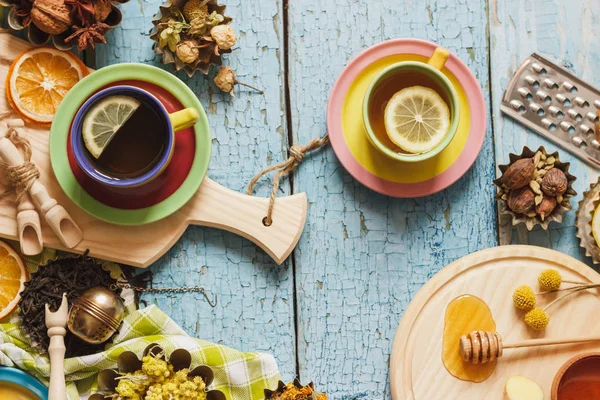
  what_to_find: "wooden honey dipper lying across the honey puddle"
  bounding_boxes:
[460,331,600,364]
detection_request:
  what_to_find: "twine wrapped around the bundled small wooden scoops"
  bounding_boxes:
[0,127,40,201]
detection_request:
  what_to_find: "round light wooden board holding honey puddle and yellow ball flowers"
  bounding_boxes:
[390,246,600,400]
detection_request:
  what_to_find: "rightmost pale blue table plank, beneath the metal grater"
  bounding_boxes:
[489,0,600,265]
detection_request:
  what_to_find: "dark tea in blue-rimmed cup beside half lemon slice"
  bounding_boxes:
[86,102,170,179]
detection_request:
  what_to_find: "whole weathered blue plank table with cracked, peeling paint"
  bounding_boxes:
[91,0,600,400]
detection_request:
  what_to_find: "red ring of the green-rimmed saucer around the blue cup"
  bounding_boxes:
[67,80,196,210]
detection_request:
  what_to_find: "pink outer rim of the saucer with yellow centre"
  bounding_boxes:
[327,39,487,198]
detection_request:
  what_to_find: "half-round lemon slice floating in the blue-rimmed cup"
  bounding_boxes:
[81,95,140,158]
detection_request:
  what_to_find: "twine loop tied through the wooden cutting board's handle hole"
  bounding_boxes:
[248,134,329,226]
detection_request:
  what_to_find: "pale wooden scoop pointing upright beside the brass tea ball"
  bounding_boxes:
[46,294,69,400]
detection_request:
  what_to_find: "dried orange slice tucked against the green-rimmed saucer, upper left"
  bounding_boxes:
[6,47,88,126]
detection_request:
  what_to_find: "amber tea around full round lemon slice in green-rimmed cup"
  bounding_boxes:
[367,71,450,154]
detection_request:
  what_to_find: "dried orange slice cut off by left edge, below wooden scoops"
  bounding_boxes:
[0,241,28,320]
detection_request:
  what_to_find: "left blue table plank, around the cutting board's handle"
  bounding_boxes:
[96,0,295,379]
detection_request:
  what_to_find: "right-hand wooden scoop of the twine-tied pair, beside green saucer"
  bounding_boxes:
[0,126,83,249]
